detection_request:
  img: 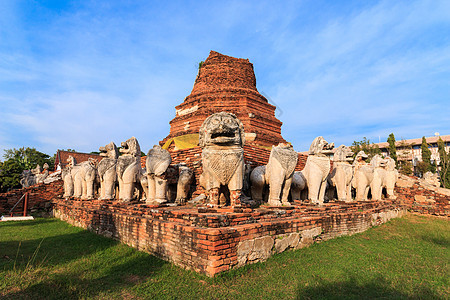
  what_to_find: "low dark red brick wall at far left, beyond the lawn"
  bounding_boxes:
[0,180,63,215]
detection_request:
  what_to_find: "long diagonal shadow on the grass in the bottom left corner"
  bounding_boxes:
[3,254,166,299]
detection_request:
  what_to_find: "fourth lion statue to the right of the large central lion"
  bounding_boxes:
[352,151,373,201]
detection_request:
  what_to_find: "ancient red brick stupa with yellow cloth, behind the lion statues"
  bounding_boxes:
[160,51,307,195]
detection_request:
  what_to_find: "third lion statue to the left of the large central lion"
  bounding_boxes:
[97,142,119,200]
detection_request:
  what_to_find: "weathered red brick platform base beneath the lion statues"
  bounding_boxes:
[53,199,406,276]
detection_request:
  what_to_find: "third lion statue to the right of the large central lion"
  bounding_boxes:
[329,145,353,202]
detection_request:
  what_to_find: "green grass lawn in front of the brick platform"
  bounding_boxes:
[0,215,450,299]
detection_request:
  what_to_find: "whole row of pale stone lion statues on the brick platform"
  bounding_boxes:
[62,112,398,206]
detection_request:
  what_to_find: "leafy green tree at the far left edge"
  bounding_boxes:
[0,147,55,192]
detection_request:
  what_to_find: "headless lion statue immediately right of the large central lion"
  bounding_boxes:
[250,144,298,206]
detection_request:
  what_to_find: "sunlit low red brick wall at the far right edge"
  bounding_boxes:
[395,176,450,216]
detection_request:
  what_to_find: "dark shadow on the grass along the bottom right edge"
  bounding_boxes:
[296,277,444,299]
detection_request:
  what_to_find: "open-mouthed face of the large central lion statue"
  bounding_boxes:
[199,112,245,148]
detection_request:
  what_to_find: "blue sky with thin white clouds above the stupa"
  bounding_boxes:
[0,0,450,155]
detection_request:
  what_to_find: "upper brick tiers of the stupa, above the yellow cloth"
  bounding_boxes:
[161,51,286,147]
